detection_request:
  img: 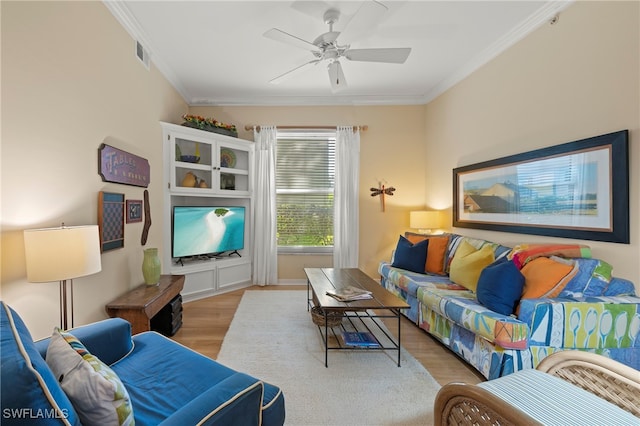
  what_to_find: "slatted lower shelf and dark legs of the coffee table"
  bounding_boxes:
[309,300,400,367]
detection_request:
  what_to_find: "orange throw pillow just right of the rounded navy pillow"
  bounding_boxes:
[520,257,578,299]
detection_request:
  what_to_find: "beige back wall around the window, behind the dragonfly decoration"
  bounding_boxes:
[190,105,427,282]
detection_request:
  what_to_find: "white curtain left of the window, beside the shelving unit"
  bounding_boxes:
[253,126,278,286]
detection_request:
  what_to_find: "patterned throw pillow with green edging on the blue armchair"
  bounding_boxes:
[46,328,134,425]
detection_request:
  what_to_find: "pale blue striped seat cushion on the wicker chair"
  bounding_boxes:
[478,369,639,426]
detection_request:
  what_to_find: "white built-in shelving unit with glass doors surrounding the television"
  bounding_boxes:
[160,122,254,301]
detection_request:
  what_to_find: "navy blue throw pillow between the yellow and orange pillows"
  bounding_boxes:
[476,258,524,315]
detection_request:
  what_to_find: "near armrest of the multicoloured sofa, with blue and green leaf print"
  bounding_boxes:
[519,296,640,349]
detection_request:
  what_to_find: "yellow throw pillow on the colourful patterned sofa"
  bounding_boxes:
[449,241,495,293]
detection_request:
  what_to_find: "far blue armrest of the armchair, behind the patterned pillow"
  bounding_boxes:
[35,318,133,365]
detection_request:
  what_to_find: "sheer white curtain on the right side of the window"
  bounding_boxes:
[333,126,360,268]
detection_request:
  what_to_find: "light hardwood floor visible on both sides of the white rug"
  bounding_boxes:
[173,285,484,385]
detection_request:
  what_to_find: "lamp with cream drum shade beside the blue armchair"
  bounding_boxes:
[24,224,102,330]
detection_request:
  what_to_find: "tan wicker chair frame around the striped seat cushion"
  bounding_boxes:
[434,351,640,425]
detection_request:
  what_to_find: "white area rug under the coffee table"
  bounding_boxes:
[218,290,440,426]
